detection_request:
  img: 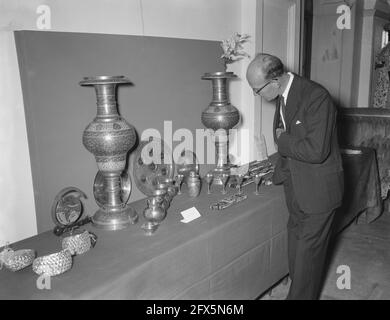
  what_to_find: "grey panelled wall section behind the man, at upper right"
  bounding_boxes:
[311,0,390,108]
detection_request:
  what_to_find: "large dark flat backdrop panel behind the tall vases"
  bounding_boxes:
[15,31,222,232]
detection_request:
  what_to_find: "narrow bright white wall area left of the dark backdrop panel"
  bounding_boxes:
[0,31,37,247]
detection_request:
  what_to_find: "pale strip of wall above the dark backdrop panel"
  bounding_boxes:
[0,0,241,40]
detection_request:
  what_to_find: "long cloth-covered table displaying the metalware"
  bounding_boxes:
[0,185,288,299]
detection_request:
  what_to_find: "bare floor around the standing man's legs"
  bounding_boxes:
[260,212,390,300]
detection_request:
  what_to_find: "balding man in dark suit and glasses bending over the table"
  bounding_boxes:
[247,54,344,300]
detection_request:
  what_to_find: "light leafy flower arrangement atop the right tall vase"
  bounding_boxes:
[221,32,250,69]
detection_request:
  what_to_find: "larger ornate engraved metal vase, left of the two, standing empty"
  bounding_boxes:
[80,76,138,230]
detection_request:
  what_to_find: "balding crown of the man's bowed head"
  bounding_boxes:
[246,53,284,83]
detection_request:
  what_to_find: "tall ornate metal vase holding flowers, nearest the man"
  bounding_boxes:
[202,72,240,185]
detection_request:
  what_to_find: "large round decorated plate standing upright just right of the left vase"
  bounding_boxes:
[133,137,175,197]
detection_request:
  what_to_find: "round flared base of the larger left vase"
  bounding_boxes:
[92,206,138,230]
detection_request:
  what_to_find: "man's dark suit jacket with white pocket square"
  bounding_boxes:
[273,74,344,213]
